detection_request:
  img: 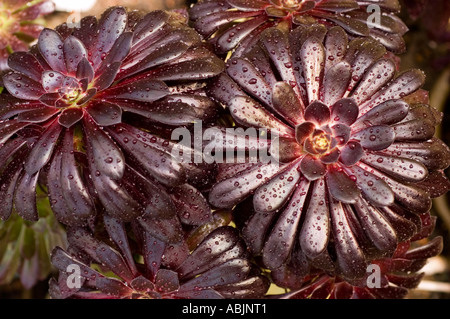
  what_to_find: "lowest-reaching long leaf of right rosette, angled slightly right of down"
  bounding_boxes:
[330,199,367,278]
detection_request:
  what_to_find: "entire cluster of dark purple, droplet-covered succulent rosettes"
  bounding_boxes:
[0,0,450,298]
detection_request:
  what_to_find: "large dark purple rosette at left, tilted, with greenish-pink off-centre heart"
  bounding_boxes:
[0,7,224,230]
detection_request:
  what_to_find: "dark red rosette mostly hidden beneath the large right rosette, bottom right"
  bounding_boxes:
[274,217,443,299]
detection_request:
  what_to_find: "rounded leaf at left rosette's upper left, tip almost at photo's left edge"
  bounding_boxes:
[3,72,45,100]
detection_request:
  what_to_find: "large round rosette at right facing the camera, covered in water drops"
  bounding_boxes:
[209,25,450,280]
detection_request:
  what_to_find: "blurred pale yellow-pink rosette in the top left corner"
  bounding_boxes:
[0,0,55,72]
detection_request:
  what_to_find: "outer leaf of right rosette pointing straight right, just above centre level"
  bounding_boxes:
[392,119,435,142]
